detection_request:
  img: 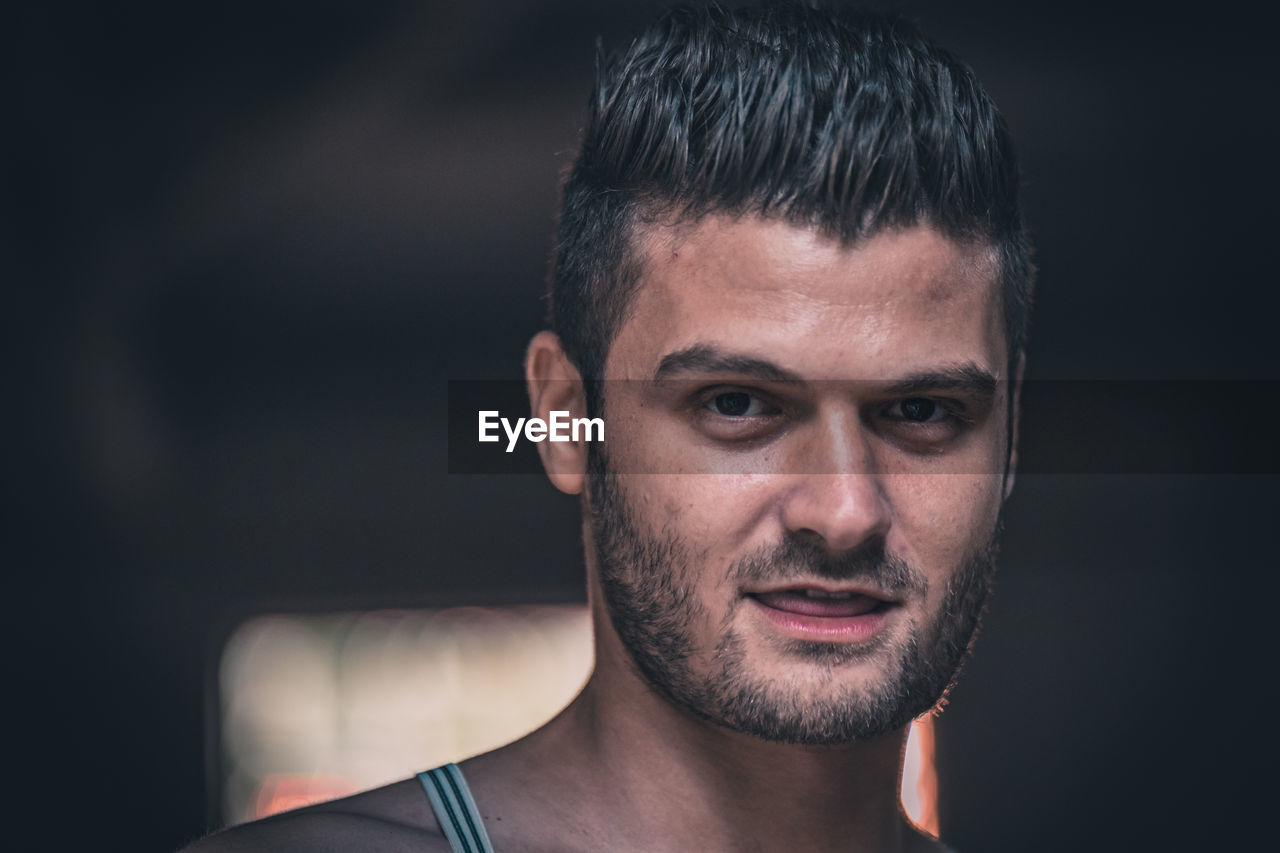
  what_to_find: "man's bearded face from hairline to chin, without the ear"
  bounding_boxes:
[588,216,1009,744]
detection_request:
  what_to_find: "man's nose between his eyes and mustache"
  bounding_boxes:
[782,409,892,551]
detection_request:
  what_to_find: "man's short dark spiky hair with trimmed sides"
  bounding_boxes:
[550,3,1034,410]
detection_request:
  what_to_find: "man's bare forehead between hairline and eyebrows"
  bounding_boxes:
[605,215,1005,379]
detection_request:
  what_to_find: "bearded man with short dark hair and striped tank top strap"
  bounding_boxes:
[186,6,1032,853]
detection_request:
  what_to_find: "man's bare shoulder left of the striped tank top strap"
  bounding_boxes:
[182,779,449,853]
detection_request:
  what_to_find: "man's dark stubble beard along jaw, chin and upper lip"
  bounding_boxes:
[588,453,1001,745]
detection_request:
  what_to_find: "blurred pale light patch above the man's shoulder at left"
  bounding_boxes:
[218,605,593,824]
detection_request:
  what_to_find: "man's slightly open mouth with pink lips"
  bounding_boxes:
[746,585,902,643]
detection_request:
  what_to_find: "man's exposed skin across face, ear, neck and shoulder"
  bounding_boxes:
[183,216,1011,853]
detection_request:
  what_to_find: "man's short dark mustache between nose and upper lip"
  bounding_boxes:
[728,537,929,596]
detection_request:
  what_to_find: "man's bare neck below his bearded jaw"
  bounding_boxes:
[486,617,925,853]
